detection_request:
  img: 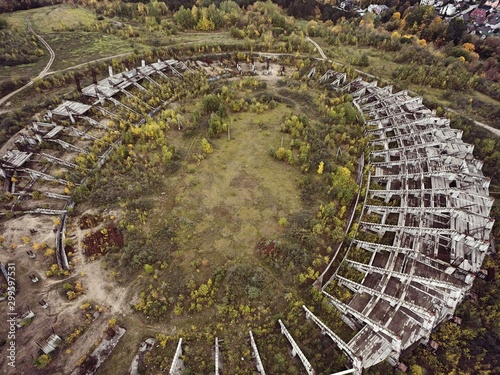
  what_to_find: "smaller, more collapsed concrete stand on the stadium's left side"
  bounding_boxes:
[0,60,189,276]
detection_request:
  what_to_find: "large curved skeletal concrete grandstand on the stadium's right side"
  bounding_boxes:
[284,70,494,374]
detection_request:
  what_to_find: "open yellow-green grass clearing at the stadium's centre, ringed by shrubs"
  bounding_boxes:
[157,105,301,280]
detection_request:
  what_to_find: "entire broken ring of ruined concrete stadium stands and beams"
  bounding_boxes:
[0,60,493,375]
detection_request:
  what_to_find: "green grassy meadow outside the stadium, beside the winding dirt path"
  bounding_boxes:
[0,5,243,108]
